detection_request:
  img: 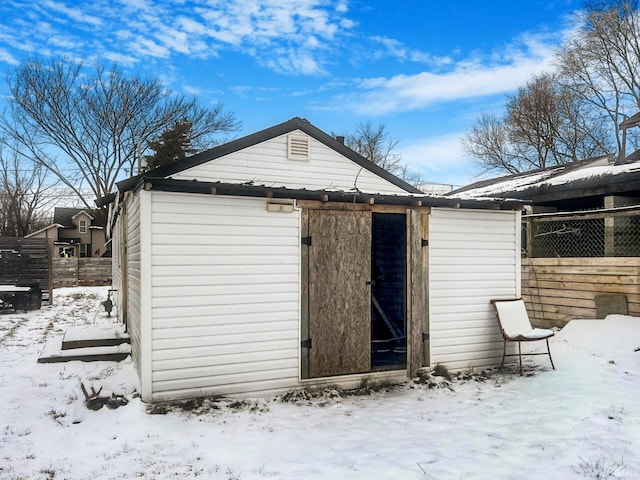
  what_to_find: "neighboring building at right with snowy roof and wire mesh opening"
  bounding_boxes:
[450,156,640,257]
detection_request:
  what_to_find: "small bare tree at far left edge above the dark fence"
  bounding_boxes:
[0,142,55,237]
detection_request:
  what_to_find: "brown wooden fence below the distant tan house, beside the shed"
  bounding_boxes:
[52,257,111,288]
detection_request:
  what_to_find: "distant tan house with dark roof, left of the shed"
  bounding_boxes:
[25,207,108,258]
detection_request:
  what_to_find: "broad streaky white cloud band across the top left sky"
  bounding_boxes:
[0,0,355,75]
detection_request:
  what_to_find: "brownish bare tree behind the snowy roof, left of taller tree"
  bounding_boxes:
[462,74,609,173]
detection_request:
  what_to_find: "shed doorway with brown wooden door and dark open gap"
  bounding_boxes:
[302,210,427,378]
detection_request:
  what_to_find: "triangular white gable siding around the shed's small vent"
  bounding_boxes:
[173,131,406,194]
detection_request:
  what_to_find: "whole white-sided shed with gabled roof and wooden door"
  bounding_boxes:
[97,118,522,401]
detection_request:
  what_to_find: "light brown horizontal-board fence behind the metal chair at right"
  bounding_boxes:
[522,257,640,327]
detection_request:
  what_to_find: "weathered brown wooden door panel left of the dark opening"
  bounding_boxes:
[309,210,371,377]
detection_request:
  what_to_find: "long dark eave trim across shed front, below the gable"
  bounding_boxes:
[130,177,528,210]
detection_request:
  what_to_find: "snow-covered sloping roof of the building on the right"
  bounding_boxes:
[449,155,640,202]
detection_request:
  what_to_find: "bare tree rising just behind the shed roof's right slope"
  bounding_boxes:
[334,122,421,185]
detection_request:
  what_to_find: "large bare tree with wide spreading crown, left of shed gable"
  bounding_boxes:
[0,58,238,207]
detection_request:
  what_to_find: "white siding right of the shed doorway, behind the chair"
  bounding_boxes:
[429,208,520,369]
